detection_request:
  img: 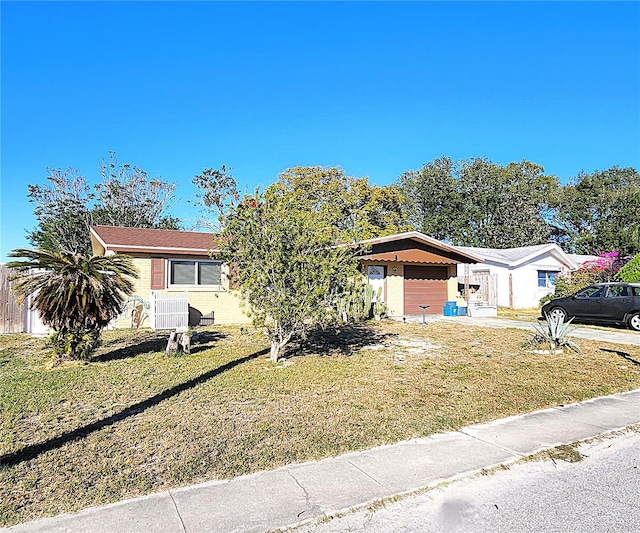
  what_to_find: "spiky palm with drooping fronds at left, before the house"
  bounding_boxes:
[7,248,138,359]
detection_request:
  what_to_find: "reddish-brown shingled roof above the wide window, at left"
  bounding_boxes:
[91,226,219,255]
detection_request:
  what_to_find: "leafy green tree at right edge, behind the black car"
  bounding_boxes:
[553,166,640,255]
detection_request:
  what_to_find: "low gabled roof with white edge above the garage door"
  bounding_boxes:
[358,231,483,264]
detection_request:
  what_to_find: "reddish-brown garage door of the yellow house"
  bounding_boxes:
[404,265,447,315]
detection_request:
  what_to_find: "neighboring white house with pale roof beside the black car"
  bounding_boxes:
[456,244,579,309]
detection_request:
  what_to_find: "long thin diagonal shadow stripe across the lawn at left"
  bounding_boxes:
[0,348,269,468]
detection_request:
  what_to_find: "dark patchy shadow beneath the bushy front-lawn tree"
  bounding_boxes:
[285,323,398,357]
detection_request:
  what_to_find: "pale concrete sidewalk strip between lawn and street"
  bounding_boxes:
[2,389,640,533]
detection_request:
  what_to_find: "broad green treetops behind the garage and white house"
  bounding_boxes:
[397,157,559,248]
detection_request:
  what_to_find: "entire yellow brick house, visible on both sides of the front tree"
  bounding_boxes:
[91,226,482,329]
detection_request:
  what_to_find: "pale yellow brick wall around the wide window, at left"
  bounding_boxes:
[116,257,251,328]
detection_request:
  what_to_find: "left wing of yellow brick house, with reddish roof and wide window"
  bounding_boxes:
[91,226,250,329]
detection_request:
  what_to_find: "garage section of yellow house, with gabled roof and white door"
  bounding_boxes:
[359,231,482,317]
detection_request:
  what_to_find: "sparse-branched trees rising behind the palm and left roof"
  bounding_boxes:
[27,152,180,255]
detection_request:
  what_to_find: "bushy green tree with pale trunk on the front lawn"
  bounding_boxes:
[221,186,357,362]
